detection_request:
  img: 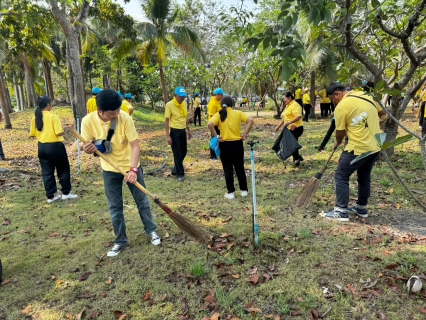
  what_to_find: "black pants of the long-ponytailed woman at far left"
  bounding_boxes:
[38,142,71,199]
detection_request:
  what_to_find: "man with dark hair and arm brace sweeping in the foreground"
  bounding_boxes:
[81,89,161,257]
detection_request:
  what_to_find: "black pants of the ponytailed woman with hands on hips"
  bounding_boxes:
[219,140,248,193]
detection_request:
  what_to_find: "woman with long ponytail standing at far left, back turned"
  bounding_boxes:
[30,96,77,203]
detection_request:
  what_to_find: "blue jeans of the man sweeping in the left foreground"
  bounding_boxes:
[104,167,157,246]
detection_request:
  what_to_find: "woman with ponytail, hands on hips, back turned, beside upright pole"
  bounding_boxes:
[208,95,253,199]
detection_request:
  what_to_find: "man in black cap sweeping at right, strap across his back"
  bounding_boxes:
[325,84,382,221]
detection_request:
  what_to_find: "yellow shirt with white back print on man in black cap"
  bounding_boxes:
[334,91,382,156]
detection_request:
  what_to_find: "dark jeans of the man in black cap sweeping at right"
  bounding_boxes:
[334,151,379,213]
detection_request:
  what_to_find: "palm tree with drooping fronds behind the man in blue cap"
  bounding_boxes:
[136,0,204,103]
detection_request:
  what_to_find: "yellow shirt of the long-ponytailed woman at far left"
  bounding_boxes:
[30,111,64,143]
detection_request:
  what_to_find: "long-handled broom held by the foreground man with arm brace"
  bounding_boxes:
[69,129,212,244]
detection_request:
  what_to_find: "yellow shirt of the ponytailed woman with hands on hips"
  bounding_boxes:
[210,107,249,141]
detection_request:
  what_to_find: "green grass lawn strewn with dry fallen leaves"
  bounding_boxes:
[0,107,426,320]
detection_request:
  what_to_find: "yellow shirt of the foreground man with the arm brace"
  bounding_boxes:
[81,110,140,172]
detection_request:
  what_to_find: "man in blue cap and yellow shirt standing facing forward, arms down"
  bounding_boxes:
[164,87,192,182]
